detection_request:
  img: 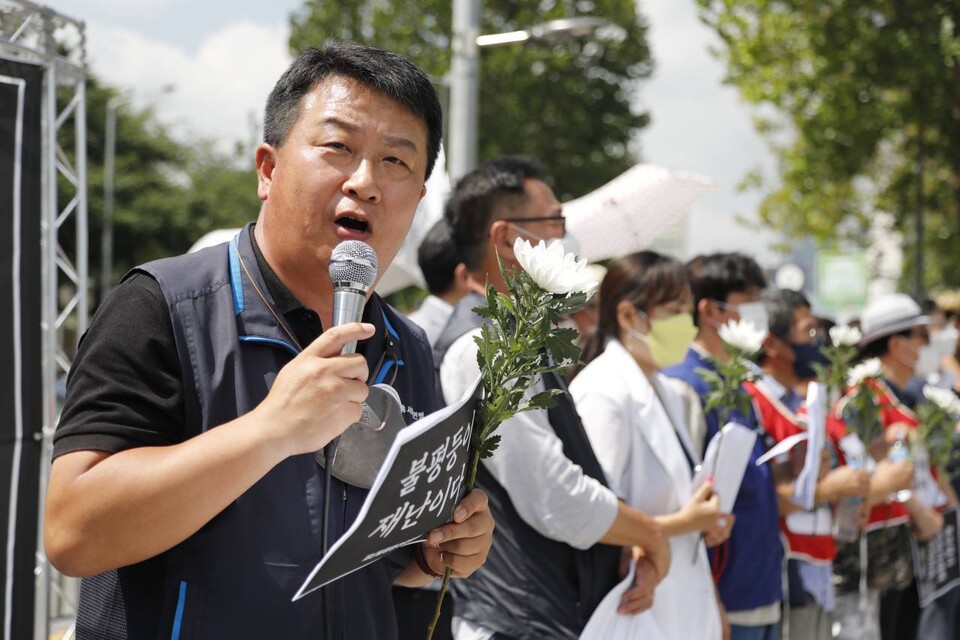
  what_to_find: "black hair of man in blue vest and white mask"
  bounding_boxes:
[687,253,767,326]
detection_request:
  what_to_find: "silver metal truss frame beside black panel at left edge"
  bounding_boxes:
[0,0,90,640]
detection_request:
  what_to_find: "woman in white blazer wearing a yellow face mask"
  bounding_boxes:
[570,251,733,640]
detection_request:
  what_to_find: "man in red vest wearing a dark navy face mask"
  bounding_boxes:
[744,290,870,640]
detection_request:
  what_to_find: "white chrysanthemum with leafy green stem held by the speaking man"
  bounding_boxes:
[427,238,597,640]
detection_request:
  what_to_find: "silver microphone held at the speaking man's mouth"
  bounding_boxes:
[330,240,379,355]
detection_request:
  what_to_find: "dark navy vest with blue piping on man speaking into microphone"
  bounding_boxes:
[77,226,439,640]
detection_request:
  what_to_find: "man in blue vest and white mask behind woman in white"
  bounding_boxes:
[664,253,783,640]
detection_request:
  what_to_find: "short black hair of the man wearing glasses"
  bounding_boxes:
[443,156,544,271]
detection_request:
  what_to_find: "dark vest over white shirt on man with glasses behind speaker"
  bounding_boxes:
[434,294,620,640]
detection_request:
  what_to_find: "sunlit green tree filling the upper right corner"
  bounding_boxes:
[697,0,960,288]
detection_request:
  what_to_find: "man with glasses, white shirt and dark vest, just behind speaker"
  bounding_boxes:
[435,158,670,640]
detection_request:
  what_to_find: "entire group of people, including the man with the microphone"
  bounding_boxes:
[44,44,960,640]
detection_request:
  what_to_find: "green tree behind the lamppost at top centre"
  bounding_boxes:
[290,0,652,199]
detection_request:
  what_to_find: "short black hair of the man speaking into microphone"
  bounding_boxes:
[263,42,443,180]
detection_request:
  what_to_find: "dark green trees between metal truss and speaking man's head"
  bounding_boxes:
[60,77,260,304]
